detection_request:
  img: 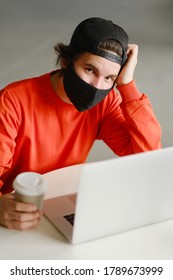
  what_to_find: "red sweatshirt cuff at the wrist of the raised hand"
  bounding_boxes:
[117,80,142,102]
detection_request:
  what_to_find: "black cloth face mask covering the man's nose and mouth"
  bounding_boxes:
[63,63,114,112]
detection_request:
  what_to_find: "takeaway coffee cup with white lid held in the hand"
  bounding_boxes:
[13,172,48,210]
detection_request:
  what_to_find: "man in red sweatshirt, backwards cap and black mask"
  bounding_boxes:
[0,18,161,230]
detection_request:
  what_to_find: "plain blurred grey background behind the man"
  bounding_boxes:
[0,0,173,161]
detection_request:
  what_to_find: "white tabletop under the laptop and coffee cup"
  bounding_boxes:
[0,164,173,260]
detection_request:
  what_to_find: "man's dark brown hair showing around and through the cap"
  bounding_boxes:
[54,40,123,76]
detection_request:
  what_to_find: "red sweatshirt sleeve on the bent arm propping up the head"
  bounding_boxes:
[97,81,162,156]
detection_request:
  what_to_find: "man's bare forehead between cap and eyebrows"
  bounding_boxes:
[75,52,121,75]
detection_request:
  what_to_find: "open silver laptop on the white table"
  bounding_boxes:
[43,147,173,244]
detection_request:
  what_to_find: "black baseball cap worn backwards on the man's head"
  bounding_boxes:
[70,17,129,65]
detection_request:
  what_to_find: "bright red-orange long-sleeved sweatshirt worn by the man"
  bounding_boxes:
[0,73,161,194]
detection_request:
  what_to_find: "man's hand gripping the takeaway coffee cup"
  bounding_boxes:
[0,194,41,230]
